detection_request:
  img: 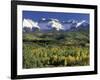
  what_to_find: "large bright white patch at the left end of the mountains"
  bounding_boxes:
[23,19,40,29]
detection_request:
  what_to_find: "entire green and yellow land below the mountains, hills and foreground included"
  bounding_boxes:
[23,31,89,69]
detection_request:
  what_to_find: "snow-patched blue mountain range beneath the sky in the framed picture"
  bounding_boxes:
[23,18,89,32]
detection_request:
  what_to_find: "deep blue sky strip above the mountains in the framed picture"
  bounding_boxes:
[23,11,89,22]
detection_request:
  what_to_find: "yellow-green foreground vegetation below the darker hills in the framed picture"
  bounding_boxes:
[23,44,89,68]
